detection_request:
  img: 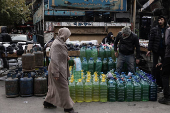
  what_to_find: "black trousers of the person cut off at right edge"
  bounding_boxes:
[161,57,170,98]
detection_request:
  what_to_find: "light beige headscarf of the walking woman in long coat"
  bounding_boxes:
[58,27,71,42]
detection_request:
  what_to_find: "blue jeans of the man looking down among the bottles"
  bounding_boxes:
[116,53,135,74]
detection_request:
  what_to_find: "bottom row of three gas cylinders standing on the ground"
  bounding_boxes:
[5,67,48,97]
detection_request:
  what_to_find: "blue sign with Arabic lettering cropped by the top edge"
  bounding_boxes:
[49,0,127,11]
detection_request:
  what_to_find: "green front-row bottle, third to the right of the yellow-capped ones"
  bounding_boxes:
[125,79,133,102]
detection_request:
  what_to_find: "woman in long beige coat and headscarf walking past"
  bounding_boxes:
[44,28,77,113]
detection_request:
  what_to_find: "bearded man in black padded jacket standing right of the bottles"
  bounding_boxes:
[146,16,167,82]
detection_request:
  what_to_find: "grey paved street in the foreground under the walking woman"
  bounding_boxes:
[0,81,170,113]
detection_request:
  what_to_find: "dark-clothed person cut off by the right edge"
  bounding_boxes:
[158,19,170,104]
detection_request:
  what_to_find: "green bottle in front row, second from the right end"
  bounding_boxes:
[141,79,149,101]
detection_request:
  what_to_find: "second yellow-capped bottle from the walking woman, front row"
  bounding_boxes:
[76,79,84,102]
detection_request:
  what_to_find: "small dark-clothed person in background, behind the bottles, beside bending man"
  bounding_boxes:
[102,32,114,44]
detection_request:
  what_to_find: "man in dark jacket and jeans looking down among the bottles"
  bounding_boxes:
[114,26,140,74]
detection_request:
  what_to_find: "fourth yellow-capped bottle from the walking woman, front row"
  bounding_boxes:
[92,78,100,102]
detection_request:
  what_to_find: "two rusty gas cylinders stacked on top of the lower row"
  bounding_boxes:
[22,45,44,72]
